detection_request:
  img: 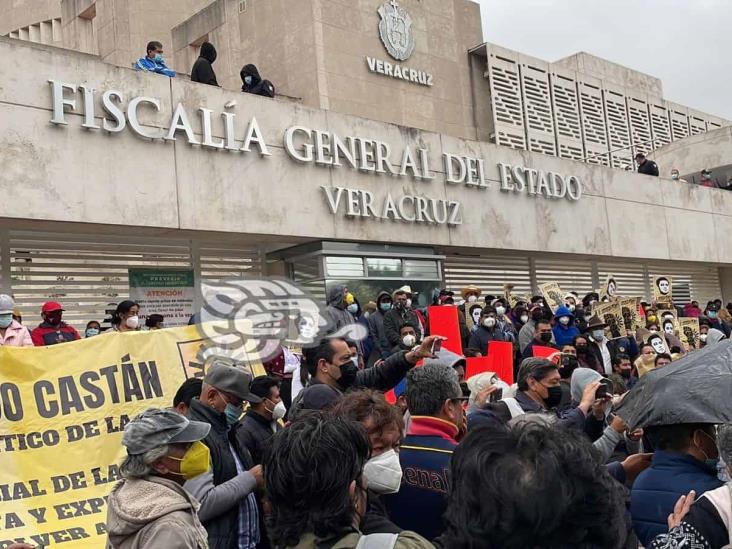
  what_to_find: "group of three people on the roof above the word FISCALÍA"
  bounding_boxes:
[132,40,275,97]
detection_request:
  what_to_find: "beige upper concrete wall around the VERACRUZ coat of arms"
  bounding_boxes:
[173,0,482,138]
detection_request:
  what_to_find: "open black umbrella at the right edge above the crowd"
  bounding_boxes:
[615,340,732,429]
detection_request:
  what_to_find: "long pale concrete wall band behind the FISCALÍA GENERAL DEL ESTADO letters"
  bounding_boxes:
[0,35,732,265]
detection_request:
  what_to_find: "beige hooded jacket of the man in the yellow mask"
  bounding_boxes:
[107,476,208,549]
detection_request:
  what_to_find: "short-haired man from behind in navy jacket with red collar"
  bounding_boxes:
[383,362,467,540]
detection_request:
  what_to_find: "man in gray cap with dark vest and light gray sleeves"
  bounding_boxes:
[185,358,262,549]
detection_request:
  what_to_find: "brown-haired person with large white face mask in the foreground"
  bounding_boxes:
[331,389,404,534]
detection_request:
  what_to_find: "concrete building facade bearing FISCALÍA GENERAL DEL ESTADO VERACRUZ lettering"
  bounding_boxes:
[0,0,732,323]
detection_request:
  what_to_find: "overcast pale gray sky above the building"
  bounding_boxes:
[476,0,732,119]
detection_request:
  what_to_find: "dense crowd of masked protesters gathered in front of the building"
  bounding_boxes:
[0,278,732,549]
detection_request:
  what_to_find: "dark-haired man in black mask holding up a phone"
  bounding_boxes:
[487,358,600,430]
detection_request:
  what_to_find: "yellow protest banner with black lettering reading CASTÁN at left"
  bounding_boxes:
[0,326,264,549]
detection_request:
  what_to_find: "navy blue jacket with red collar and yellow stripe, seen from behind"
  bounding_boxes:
[382,416,457,540]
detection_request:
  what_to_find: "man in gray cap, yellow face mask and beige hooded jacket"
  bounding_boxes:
[107,408,211,549]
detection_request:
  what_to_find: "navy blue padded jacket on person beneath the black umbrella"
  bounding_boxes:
[630,450,724,547]
